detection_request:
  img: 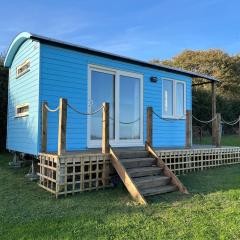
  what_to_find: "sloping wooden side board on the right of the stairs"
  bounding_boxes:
[145,142,189,194]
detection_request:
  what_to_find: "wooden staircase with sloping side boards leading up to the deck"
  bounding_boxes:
[110,144,188,204]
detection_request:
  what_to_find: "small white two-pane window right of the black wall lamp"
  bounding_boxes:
[162,79,186,118]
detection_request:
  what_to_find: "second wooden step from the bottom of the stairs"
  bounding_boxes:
[133,175,171,190]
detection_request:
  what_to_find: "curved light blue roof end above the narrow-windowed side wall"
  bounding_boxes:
[4,32,32,68]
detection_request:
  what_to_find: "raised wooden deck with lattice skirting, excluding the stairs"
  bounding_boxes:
[39,145,240,197]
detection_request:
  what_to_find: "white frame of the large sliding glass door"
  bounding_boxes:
[87,64,144,148]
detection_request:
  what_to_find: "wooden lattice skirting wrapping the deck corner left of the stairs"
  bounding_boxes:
[38,153,110,197]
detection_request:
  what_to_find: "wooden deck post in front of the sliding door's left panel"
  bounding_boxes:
[102,102,109,154]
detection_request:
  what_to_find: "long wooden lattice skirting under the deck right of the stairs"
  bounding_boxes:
[157,147,240,175]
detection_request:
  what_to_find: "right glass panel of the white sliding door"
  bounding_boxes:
[119,76,141,140]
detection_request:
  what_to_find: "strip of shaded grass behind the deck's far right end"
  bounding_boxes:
[193,135,240,147]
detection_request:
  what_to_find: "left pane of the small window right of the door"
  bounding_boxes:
[163,80,173,116]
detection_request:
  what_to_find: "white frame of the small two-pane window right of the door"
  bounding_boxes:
[162,78,187,119]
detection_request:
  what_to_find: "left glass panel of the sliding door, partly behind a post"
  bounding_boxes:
[90,71,115,140]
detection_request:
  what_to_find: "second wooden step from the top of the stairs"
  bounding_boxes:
[120,158,156,168]
